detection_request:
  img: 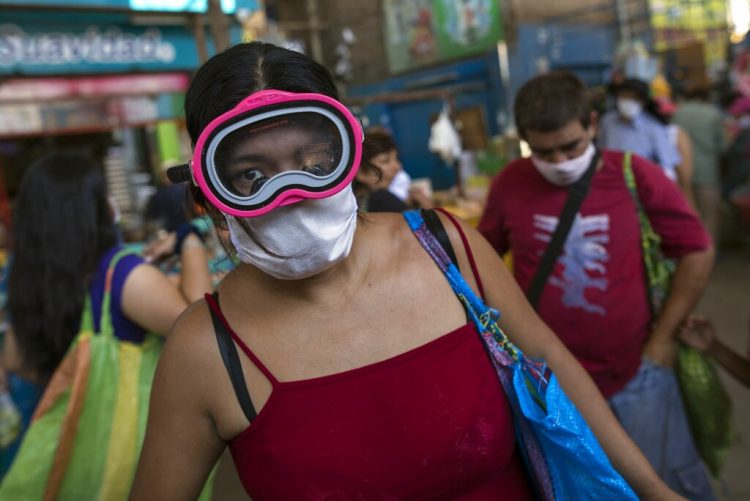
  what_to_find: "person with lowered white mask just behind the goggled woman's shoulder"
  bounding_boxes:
[354,127,432,212]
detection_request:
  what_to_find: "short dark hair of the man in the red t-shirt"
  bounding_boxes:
[513,71,591,137]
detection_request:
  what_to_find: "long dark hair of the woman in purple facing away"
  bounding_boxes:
[8,152,117,380]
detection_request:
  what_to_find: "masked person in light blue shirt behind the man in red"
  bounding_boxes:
[598,78,681,181]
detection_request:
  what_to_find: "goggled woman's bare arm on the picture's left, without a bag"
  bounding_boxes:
[130,303,229,501]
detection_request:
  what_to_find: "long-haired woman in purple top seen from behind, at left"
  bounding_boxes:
[2,151,211,476]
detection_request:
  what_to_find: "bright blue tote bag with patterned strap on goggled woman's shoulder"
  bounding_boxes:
[404,211,638,501]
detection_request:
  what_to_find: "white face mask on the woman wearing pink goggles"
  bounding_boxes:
[225,186,357,280]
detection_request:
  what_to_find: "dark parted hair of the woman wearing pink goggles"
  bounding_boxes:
[185,42,339,249]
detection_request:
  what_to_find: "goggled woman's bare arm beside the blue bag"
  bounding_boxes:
[441,216,680,499]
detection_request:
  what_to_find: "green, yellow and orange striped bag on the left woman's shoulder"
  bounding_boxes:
[0,251,211,501]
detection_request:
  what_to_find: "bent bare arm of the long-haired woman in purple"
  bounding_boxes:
[122,234,212,334]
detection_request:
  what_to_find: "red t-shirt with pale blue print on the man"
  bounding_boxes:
[479,151,709,397]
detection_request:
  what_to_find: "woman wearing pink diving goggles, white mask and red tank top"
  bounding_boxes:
[131,43,680,500]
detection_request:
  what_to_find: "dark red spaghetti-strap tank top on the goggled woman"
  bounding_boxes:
[206,210,533,501]
